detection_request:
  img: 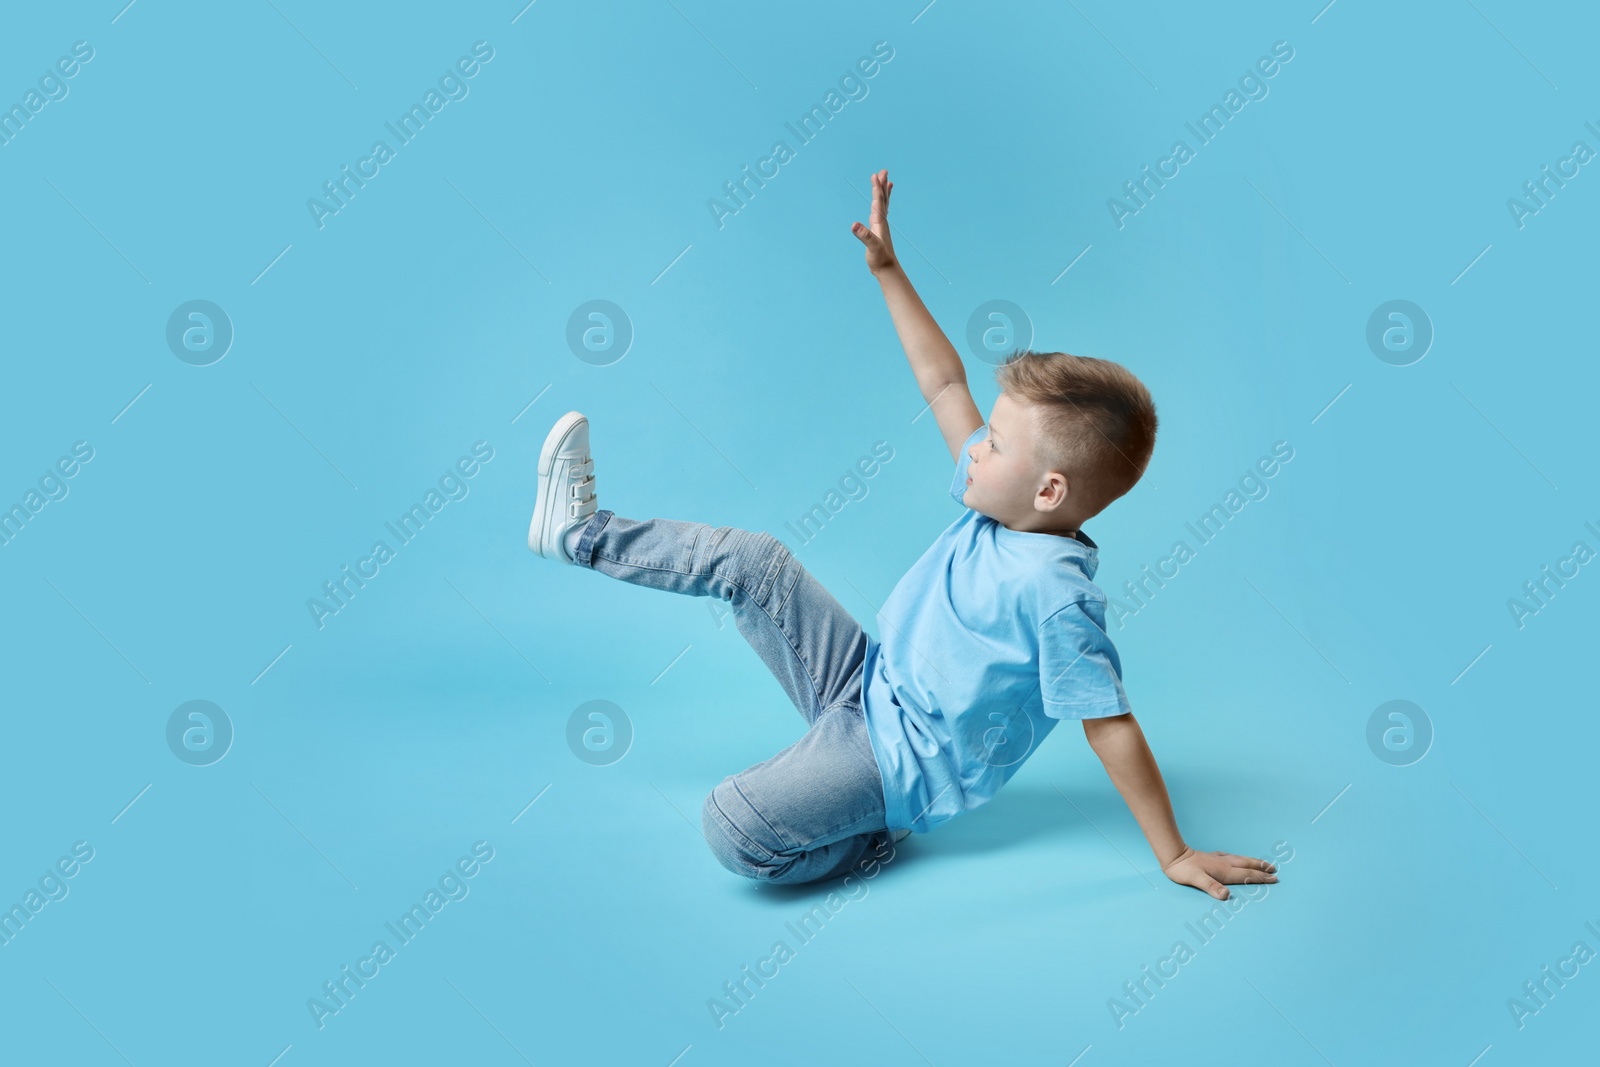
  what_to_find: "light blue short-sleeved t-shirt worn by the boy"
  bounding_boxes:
[861,426,1133,833]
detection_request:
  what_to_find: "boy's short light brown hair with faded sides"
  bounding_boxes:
[995,349,1157,515]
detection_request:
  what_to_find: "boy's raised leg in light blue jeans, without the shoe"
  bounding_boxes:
[573,509,882,726]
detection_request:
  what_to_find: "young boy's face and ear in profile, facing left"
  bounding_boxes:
[962,394,1066,530]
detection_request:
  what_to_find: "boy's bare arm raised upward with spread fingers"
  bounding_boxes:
[850,170,984,461]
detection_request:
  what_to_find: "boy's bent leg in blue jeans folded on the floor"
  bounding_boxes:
[701,700,894,885]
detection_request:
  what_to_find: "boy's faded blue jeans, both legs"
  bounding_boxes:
[574,510,890,885]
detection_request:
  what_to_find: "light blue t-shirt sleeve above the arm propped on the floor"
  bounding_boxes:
[1038,600,1133,718]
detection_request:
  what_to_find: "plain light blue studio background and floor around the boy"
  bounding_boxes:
[0,0,1600,1067]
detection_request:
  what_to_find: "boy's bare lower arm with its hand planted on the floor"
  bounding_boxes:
[1083,712,1278,901]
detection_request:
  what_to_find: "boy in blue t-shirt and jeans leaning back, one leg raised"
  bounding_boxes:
[528,170,1277,901]
